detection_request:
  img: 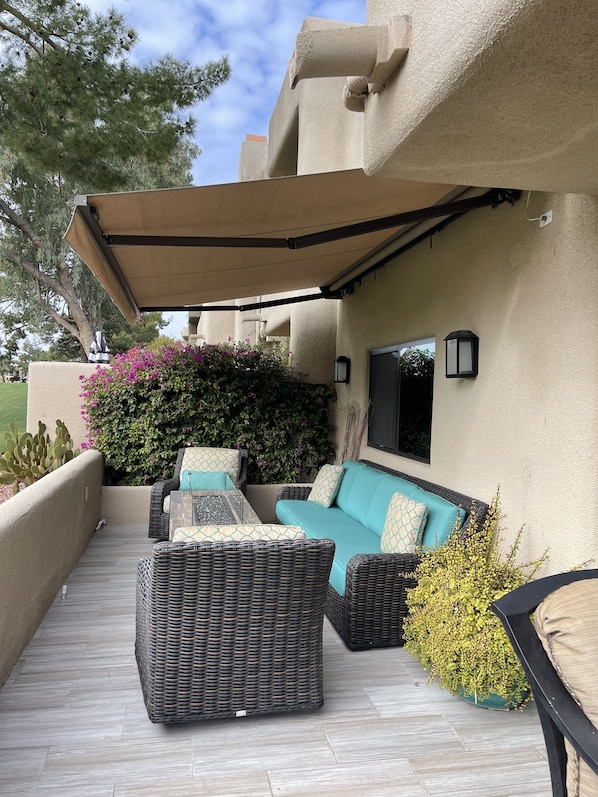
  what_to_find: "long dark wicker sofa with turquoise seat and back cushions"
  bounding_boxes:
[276,460,488,650]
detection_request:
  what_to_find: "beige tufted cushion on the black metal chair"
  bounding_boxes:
[533,579,598,797]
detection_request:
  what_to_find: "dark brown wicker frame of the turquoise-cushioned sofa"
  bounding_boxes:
[276,460,488,650]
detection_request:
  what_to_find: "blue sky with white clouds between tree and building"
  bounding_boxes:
[86,0,366,339]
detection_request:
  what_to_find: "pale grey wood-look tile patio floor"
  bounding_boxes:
[0,526,551,797]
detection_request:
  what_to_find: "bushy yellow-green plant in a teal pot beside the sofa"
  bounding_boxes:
[404,492,547,708]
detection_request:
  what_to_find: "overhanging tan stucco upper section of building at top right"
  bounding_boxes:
[364,0,598,194]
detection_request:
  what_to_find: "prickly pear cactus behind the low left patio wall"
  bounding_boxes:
[0,420,79,495]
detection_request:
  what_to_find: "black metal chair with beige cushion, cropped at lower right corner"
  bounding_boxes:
[492,570,598,797]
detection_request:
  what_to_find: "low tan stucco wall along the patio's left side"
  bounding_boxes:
[0,451,104,686]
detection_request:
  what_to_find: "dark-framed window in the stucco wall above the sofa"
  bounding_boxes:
[368,339,435,462]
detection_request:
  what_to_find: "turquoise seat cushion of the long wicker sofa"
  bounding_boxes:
[276,499,380,595]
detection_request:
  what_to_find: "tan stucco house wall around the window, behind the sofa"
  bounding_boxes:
[337,194,598,571]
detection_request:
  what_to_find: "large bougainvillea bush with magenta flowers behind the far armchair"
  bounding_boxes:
[82,343,333,485]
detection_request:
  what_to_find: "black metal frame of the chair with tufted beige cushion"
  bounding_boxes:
[492,570,598,797]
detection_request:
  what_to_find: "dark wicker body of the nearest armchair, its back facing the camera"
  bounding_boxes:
[135,540,334,723]
